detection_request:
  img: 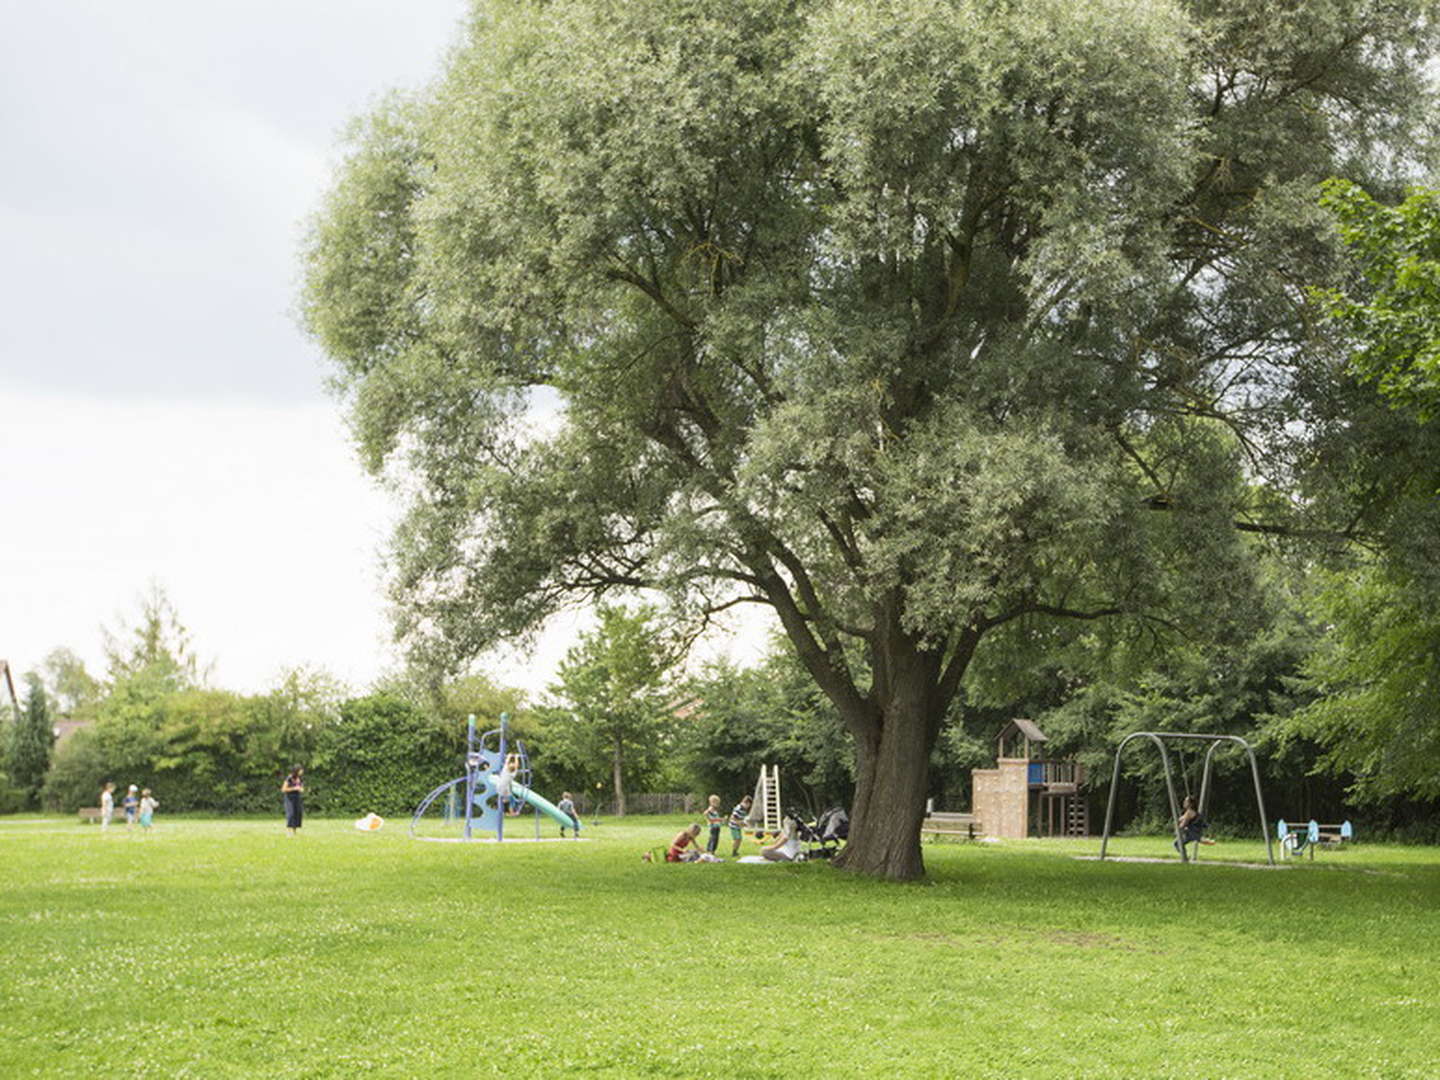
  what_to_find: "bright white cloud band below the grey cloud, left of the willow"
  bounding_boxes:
[0,393,392,690]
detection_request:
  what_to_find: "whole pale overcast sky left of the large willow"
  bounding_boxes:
[0,0,515,702]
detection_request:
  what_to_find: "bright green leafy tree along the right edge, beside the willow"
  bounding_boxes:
[1276,180,1440,802]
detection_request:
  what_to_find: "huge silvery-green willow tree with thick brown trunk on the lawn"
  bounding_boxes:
[307,0,1431,878]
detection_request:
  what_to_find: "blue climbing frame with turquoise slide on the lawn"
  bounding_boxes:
[410,713,580,841]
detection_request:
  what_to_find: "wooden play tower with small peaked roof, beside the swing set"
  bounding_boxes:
[971,719,1090,840]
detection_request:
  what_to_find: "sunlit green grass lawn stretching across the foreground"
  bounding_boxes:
[0,815,1440,1080]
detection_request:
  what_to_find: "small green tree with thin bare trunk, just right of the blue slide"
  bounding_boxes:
[541,605,675,816]
